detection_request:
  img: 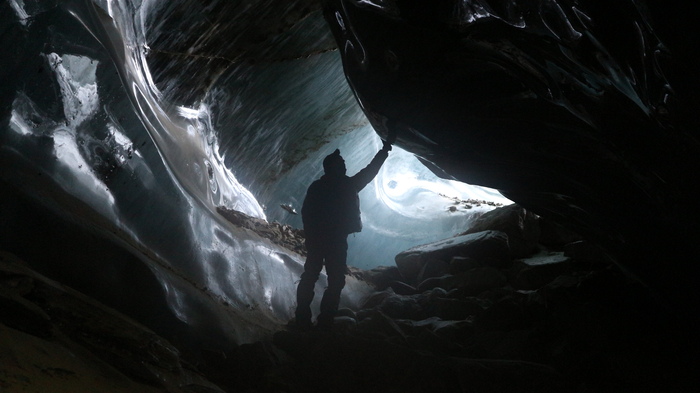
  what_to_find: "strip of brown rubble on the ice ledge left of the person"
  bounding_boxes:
[216,206,306,256]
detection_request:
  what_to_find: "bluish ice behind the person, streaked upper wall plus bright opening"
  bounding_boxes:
[180,5,509,268]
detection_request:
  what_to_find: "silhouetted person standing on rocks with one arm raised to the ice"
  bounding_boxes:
[296,142,391,328]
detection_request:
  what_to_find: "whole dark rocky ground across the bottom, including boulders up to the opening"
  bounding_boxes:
[0,204,698,393]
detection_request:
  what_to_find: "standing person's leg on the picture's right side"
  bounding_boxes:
[318,238,348,327]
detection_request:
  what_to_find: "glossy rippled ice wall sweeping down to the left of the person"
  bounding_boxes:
[0,0,322,342]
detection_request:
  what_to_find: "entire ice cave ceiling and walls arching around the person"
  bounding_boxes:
[0,0,700,345]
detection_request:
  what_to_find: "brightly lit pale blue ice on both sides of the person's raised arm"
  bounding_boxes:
[267,124,512,269]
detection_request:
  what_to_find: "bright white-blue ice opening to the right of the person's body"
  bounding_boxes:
[348,127,512,269]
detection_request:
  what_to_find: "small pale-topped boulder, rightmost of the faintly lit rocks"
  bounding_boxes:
[511,252,572,289]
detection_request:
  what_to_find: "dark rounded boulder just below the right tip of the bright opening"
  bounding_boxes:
[463,204,540,258]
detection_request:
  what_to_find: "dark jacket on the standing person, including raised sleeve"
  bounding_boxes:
[301,149,389,240]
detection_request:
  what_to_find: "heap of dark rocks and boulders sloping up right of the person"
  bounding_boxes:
[260,207,697,392]
